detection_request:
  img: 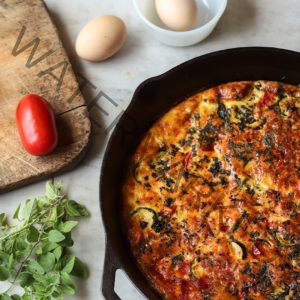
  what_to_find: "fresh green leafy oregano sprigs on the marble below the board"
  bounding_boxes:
[0,181,88,300]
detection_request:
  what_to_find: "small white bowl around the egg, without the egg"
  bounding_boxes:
[133,0,227,47]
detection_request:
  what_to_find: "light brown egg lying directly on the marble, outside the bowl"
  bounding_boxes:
[75,15,127,61]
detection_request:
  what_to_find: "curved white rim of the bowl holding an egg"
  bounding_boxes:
[132,0,227,36]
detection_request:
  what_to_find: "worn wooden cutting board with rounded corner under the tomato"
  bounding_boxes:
[0,0,91,193]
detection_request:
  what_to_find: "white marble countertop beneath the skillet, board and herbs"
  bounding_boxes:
[0,0,300,300]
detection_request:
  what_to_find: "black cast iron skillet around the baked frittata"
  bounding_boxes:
[100,47,300,300]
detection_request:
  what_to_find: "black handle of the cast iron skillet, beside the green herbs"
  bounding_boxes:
[102,239,121,300]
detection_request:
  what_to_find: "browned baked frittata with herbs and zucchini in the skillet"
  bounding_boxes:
[122,80,300,300]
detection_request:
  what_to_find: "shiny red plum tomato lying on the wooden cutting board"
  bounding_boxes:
[16,94,58,156]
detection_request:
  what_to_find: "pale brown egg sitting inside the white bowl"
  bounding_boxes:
[155,0,199,31]
